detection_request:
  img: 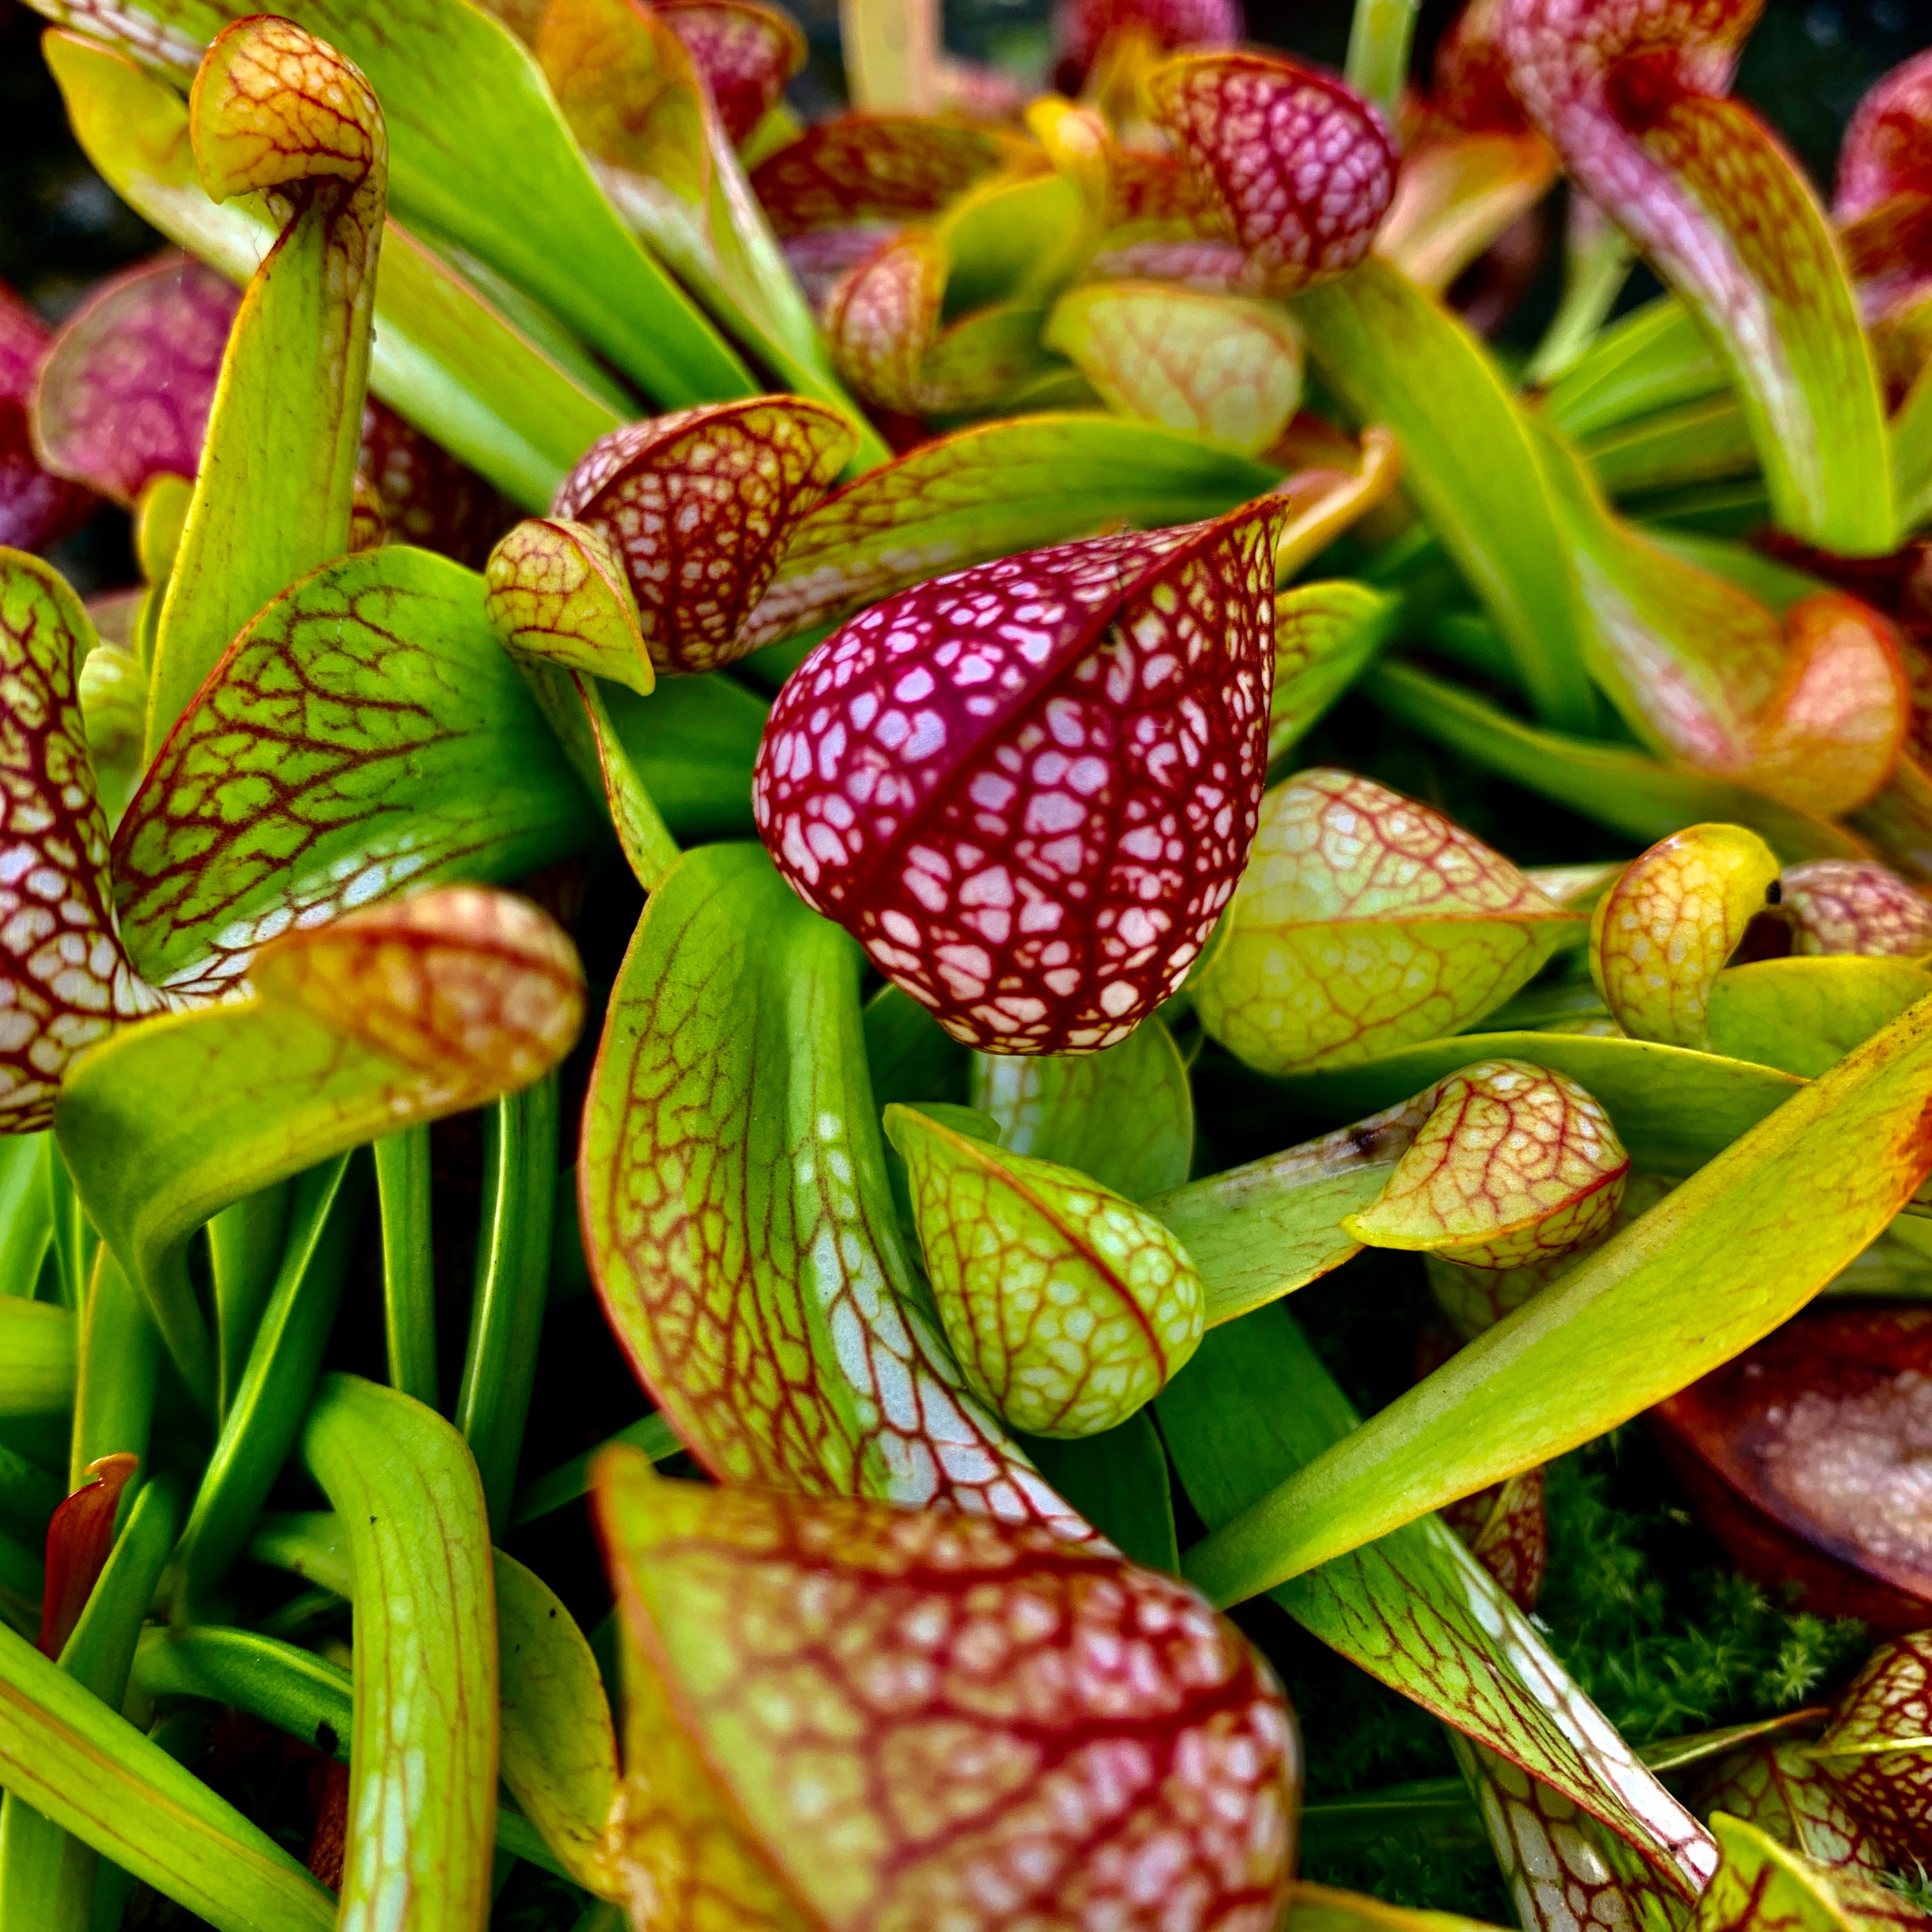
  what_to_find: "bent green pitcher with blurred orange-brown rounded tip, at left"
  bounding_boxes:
[62,889,583,1399]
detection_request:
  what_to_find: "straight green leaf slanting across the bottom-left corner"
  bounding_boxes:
[0,1627,336,1932]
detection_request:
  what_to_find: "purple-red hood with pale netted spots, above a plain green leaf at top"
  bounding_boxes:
[1147,54,1395,296]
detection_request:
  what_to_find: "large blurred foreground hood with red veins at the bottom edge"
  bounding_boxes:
[597,1451,1300,1932]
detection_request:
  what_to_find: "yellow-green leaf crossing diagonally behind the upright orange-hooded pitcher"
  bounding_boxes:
[45,33,620,510]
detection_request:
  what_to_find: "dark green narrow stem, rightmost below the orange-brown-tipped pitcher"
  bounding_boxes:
[456,1074,558,1534]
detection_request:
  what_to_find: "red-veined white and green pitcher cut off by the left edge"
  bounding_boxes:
[0,553,164,1134]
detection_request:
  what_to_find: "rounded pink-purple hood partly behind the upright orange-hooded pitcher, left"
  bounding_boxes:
[33,255,241,506]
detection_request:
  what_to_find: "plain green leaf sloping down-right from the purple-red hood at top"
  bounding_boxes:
[1294,257,1592,730]
